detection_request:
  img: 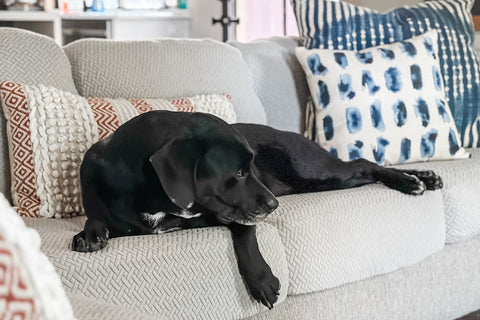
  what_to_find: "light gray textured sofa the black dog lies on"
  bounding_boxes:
[0,28,480,319]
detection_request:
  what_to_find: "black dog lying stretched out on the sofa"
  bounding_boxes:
[72,111,442,308]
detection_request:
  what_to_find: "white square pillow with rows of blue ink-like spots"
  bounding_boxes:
[296,31,469,165]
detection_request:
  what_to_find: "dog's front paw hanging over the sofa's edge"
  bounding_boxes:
[245,269,280,309]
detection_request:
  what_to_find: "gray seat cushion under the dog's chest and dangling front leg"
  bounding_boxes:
[25,217,288,319]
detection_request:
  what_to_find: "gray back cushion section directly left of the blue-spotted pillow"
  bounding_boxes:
[230,37,310,133]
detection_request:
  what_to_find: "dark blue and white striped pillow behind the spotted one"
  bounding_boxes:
[291,0,480,147]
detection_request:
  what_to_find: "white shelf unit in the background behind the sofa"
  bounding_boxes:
[0,9,192,45]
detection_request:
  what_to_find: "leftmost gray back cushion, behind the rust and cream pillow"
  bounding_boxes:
[0,28,77,200]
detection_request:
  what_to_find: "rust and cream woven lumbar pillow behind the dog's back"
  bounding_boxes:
[0,81,236,217]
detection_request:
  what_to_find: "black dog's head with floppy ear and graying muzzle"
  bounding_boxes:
[150,114,278,224]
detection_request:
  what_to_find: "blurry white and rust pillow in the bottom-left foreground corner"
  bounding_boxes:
[0,194,75,320]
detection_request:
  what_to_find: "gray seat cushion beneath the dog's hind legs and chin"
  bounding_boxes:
[266,184,445,294]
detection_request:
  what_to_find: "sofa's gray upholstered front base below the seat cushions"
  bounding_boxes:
[248,237,480,320]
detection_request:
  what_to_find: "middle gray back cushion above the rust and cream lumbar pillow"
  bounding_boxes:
[64,39,266,124]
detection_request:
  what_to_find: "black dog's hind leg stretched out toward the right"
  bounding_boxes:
[234,124,442,196]
